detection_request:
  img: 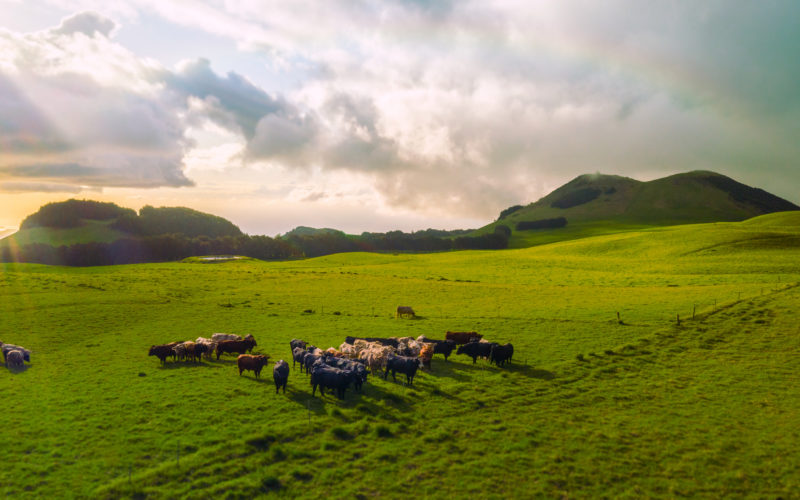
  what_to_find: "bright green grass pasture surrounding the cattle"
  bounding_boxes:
[0,213,800,498]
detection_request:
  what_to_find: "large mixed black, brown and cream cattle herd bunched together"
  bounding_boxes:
[147,331,514,399]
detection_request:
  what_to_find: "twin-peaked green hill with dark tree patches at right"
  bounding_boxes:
[479,171,800,247]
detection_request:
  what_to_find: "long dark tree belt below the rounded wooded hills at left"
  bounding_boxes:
[0,234,302,266]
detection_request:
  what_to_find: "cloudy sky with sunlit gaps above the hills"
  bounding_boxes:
[0,0,800,235]
